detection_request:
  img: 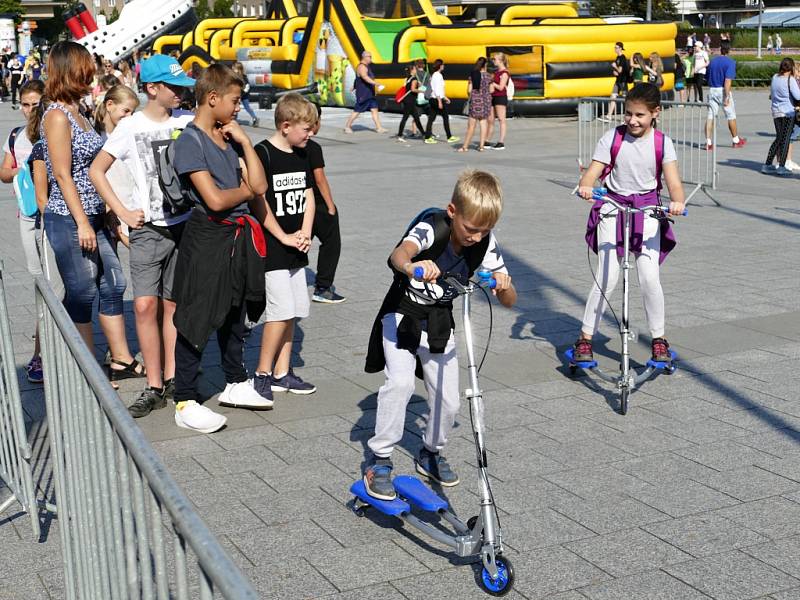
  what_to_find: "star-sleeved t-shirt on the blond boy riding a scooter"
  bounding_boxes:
[403,217,508,305]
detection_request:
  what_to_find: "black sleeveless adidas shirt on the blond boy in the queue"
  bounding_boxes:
[256,140,313,271]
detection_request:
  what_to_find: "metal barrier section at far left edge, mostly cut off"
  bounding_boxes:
[0,265,40,538]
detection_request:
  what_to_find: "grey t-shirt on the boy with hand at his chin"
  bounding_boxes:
[174,122,248,218]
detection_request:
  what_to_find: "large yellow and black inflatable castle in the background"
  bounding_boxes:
[156,0,677,114]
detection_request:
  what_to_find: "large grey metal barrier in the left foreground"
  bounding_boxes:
[36,277,258,600]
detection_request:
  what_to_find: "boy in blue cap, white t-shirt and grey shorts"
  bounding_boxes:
[89,54,200,422]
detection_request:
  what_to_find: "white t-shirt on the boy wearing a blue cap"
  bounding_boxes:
[103,112,194,227]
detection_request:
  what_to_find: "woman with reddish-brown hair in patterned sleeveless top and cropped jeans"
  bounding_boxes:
[42,42,144,379]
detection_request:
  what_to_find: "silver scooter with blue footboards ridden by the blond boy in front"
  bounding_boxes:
[350,267,514,596]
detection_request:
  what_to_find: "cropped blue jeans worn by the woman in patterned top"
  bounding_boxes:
[44,211,127,323]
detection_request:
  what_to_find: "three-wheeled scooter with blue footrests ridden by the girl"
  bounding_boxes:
[564,188,688,415]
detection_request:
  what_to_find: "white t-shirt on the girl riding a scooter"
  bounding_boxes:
[592,129,678,196]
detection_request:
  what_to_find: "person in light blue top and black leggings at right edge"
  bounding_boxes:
[761,57,800,177]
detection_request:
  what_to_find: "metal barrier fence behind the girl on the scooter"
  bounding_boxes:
[578,98,717,202]
